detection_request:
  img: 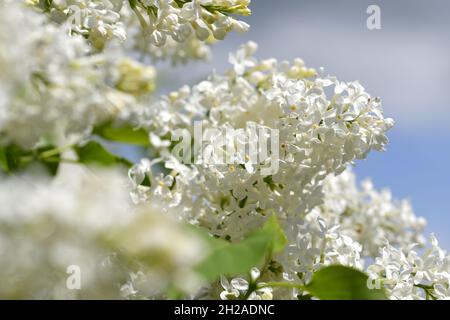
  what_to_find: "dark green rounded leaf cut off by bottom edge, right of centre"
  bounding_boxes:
[305,265,386,300]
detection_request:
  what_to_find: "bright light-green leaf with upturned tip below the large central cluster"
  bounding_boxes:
[197,215,287,281]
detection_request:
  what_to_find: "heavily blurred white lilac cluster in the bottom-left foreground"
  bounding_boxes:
[0,165,207,299]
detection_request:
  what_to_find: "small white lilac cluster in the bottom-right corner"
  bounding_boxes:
[367,235,450,300]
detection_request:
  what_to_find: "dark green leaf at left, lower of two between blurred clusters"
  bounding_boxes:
[75,141,132,167]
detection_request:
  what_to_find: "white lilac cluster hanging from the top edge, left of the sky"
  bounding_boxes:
[28,0,250,63]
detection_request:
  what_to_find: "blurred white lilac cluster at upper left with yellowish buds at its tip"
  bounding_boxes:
[0,3,156,148]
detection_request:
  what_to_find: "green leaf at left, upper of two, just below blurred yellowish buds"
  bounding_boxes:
[94,122,150,146]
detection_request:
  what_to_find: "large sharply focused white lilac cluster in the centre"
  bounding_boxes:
[131,42,393,240]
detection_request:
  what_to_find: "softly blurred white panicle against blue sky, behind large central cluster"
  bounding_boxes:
[316,170,426,257]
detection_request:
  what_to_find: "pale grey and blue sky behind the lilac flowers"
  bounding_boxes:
[152,0,450,249]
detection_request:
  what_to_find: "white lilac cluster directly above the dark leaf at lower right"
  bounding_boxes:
[278,169,428,298]
